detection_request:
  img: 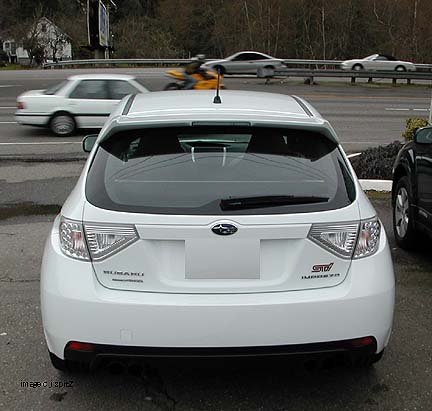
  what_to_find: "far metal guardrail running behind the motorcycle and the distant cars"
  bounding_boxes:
[42,59,432,70]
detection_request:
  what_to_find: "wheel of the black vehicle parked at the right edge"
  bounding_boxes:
[392,176,418,250]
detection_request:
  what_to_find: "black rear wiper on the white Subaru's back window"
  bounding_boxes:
[219,195,329,211]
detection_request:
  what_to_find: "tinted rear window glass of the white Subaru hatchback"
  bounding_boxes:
[86,127,355,215]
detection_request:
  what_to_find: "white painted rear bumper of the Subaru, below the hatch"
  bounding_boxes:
[41,225,394,358]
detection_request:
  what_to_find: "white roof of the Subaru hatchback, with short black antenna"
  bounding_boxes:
[121,90,323,123]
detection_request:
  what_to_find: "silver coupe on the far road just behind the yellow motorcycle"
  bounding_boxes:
[203,51,286,74]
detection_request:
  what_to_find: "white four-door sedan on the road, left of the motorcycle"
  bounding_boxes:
[15,74,148,136]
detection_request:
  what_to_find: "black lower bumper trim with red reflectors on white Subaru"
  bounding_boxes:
[64,337,377,363]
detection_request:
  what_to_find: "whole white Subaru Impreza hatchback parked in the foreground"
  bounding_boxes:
[41,91,394,369]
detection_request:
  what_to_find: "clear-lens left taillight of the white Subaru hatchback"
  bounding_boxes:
[60,217,139,261]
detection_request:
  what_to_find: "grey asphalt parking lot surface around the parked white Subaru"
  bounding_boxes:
[0,162,432,411]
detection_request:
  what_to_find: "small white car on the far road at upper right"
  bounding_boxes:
[341,54,416,71]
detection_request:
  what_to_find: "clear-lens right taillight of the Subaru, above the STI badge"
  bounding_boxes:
[308,217,381,259]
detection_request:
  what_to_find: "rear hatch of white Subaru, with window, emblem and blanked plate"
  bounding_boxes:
[83,127,359,293]
